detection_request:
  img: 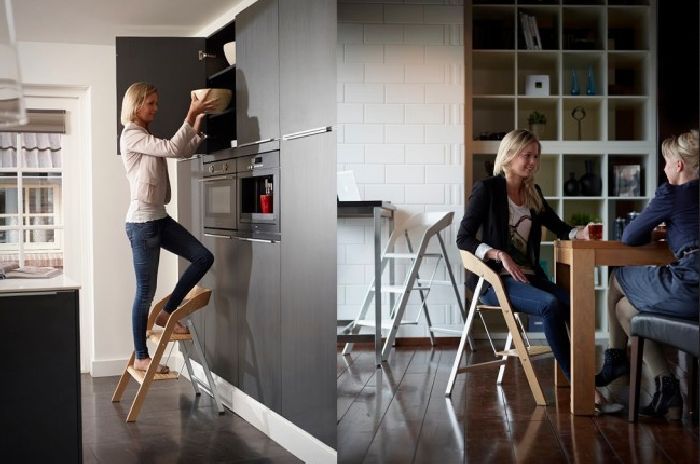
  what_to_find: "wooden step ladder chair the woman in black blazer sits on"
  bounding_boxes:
[445,250,552,406]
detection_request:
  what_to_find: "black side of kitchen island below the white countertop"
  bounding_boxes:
[0,290,82,462]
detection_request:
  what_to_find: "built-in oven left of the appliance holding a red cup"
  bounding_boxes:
[200,159,238,232]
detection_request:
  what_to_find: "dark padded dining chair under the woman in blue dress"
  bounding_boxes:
[628,313,700,422]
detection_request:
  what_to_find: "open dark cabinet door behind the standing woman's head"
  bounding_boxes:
[116,37,206,153]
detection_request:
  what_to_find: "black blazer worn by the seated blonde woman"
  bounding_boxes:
[457,176,573,289]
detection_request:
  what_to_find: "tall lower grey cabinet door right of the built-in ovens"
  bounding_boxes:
[280,132,337,446]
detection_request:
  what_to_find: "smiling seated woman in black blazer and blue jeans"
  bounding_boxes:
[457,129,589,379]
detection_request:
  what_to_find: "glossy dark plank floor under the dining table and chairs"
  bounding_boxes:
[337,347,700,464]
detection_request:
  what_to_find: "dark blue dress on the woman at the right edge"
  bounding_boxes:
[614,180,700,319]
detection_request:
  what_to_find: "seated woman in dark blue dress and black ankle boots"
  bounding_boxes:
[595,130,700,419]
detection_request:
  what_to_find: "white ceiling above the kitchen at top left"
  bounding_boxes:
[12,0,251,45]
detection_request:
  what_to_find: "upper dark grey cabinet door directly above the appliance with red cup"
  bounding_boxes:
[236,0,278,146]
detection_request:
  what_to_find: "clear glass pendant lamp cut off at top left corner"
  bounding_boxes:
[0,0,27,127]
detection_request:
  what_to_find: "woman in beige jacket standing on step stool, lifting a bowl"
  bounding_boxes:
[119,82,214,374]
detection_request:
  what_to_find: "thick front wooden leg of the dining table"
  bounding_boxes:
[569,249,596,415]
